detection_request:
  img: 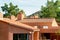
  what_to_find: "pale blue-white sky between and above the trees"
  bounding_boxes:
[0,0,47,15]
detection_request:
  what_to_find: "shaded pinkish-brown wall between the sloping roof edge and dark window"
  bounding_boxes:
[9,25,31,33]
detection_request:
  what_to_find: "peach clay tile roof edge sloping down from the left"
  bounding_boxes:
[0,18,39,31]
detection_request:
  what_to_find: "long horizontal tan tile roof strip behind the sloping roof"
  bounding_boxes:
[19,18,54,22]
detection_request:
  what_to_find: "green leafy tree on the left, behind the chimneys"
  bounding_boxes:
[1,3,19,17]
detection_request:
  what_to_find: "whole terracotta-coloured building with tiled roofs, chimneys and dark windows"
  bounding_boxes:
[0,13,60,40]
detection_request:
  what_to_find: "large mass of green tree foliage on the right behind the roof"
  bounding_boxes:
[40,0,60,21]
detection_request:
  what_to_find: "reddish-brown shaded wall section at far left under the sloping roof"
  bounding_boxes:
[0,22,8,40]
